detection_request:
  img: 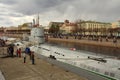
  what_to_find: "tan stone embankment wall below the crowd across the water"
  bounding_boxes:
[48,38,120,48]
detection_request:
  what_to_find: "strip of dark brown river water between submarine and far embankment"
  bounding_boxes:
[48,41,120,58]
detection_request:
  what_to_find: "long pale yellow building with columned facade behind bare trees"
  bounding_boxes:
[78,21,111,36]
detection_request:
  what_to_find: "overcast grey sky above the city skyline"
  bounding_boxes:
[0,0,120,27]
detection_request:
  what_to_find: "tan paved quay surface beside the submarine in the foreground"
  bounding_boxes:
[0,51,87,80]
